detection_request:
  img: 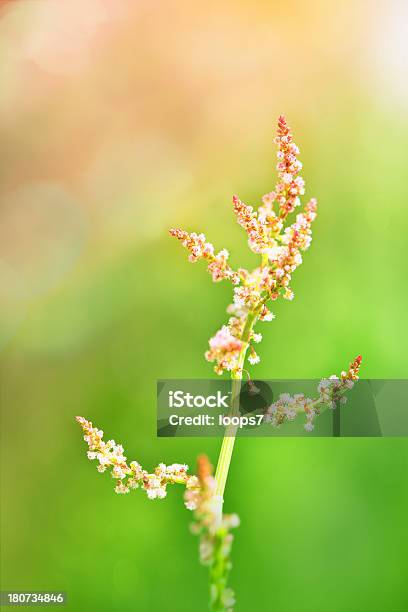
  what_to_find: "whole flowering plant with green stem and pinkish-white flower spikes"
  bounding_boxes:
[77,116,361,611]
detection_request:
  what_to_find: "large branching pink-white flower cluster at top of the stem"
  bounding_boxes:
[170,116,317,374]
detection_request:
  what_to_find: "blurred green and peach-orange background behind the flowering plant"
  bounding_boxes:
[0,0,408,612]
